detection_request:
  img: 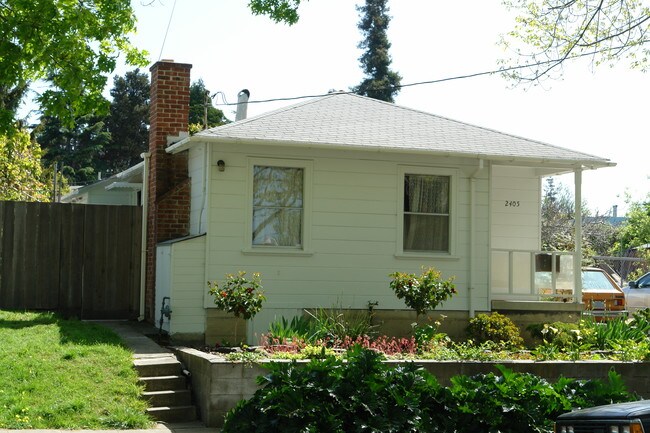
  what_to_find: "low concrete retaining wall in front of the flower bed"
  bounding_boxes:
[175,348,650,427]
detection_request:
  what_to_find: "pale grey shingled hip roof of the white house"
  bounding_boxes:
[168,93,615,168]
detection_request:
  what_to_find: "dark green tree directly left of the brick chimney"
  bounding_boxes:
[101,69,150,174]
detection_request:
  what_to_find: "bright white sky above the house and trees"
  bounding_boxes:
[116,0,650,215]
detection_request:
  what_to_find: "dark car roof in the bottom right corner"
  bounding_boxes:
[555,400,650,433]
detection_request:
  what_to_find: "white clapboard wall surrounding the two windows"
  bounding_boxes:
[195,143,490,338]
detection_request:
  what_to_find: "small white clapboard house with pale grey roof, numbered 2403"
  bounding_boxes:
[143,60,614,344]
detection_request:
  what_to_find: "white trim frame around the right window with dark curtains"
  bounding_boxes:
[395,165,459,260]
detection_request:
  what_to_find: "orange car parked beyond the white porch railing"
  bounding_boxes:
[535,268,624,318]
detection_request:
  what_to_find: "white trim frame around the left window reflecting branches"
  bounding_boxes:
[242,157,314,256]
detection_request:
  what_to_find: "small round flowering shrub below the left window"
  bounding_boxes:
[208,271,266,320]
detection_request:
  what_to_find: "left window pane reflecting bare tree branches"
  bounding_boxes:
[253,165,304,248]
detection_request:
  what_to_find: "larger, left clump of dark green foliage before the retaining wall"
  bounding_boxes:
[222,348,453,433]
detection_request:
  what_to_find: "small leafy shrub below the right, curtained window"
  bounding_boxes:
[389,268,456,316]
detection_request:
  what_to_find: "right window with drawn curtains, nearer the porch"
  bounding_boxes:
[403,174,451,252]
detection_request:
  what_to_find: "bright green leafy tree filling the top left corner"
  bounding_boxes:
[0,0,148,133]
